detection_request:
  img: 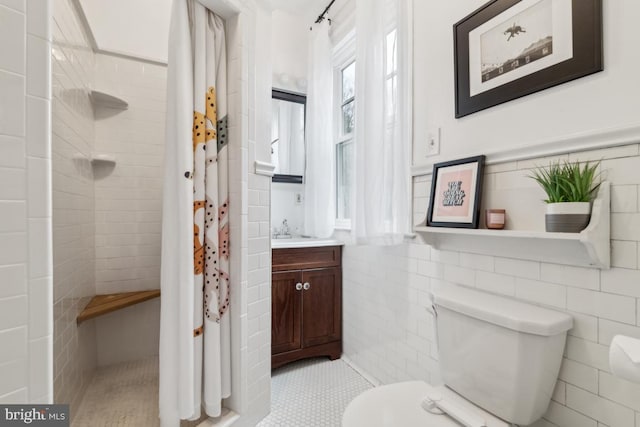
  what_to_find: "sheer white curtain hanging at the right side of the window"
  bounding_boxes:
[351,0,412,244]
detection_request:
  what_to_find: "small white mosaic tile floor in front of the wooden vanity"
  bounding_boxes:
[257,358,373,427]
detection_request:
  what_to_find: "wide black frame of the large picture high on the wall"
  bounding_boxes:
[453,0,603,118]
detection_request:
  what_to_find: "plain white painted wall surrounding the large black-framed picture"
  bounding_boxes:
[414,0,640,164]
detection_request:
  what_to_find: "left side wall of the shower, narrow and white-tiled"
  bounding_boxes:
[51,0,96,416]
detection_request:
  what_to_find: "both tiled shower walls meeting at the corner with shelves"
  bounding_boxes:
[52,1,166,408]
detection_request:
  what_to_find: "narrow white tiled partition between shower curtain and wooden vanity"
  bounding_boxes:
[240,4,271,426]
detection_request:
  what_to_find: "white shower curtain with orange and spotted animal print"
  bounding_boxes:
[159,0,231,427]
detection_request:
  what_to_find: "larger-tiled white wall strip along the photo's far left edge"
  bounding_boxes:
[0,0,53,404]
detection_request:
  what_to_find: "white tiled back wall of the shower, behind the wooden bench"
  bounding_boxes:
[93,54,167,366]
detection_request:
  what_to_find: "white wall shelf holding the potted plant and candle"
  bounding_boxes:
[414,182,611,269]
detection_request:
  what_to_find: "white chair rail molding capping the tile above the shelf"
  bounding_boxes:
[411,125,640,177]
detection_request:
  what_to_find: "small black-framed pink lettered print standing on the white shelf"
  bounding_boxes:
[427,156,485,228]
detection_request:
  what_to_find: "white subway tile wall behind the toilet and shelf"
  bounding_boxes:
[343,144,640,427]
